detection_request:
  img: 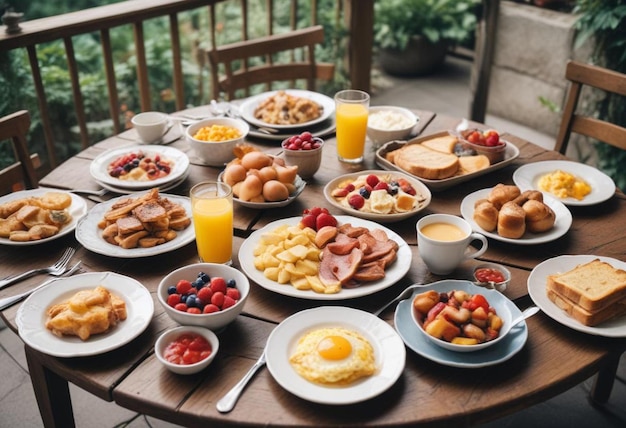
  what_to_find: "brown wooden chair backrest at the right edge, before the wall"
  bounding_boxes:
[554,61,626,154]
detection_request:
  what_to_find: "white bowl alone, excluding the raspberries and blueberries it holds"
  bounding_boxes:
[157,263,250,331]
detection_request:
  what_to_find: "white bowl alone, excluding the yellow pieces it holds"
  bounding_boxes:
[185,117,250,166]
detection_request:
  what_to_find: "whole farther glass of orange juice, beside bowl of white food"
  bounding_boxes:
[335,89,370,163]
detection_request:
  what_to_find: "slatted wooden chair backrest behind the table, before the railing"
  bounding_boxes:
[207,25,335,100]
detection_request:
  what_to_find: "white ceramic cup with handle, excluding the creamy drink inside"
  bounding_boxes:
[416,214,487,275]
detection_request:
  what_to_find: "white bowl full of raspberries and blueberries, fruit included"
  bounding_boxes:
[157,263,250,331]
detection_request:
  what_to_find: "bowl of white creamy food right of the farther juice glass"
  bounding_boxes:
[367,106,419,148]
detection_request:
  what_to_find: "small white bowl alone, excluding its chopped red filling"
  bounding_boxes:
[154,326,220,374]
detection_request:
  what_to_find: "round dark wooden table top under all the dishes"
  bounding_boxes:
[0,110,626,426]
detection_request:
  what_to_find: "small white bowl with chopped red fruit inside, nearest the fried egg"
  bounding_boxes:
[154,326,220,374]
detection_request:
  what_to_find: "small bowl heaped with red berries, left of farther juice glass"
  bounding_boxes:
[281,131,324,179]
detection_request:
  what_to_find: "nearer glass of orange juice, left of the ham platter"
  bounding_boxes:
[190,181,233,265]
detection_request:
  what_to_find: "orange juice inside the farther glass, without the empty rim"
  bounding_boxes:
[336,104,367,161]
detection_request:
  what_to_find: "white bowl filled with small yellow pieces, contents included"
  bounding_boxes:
[185,117,250,166]
